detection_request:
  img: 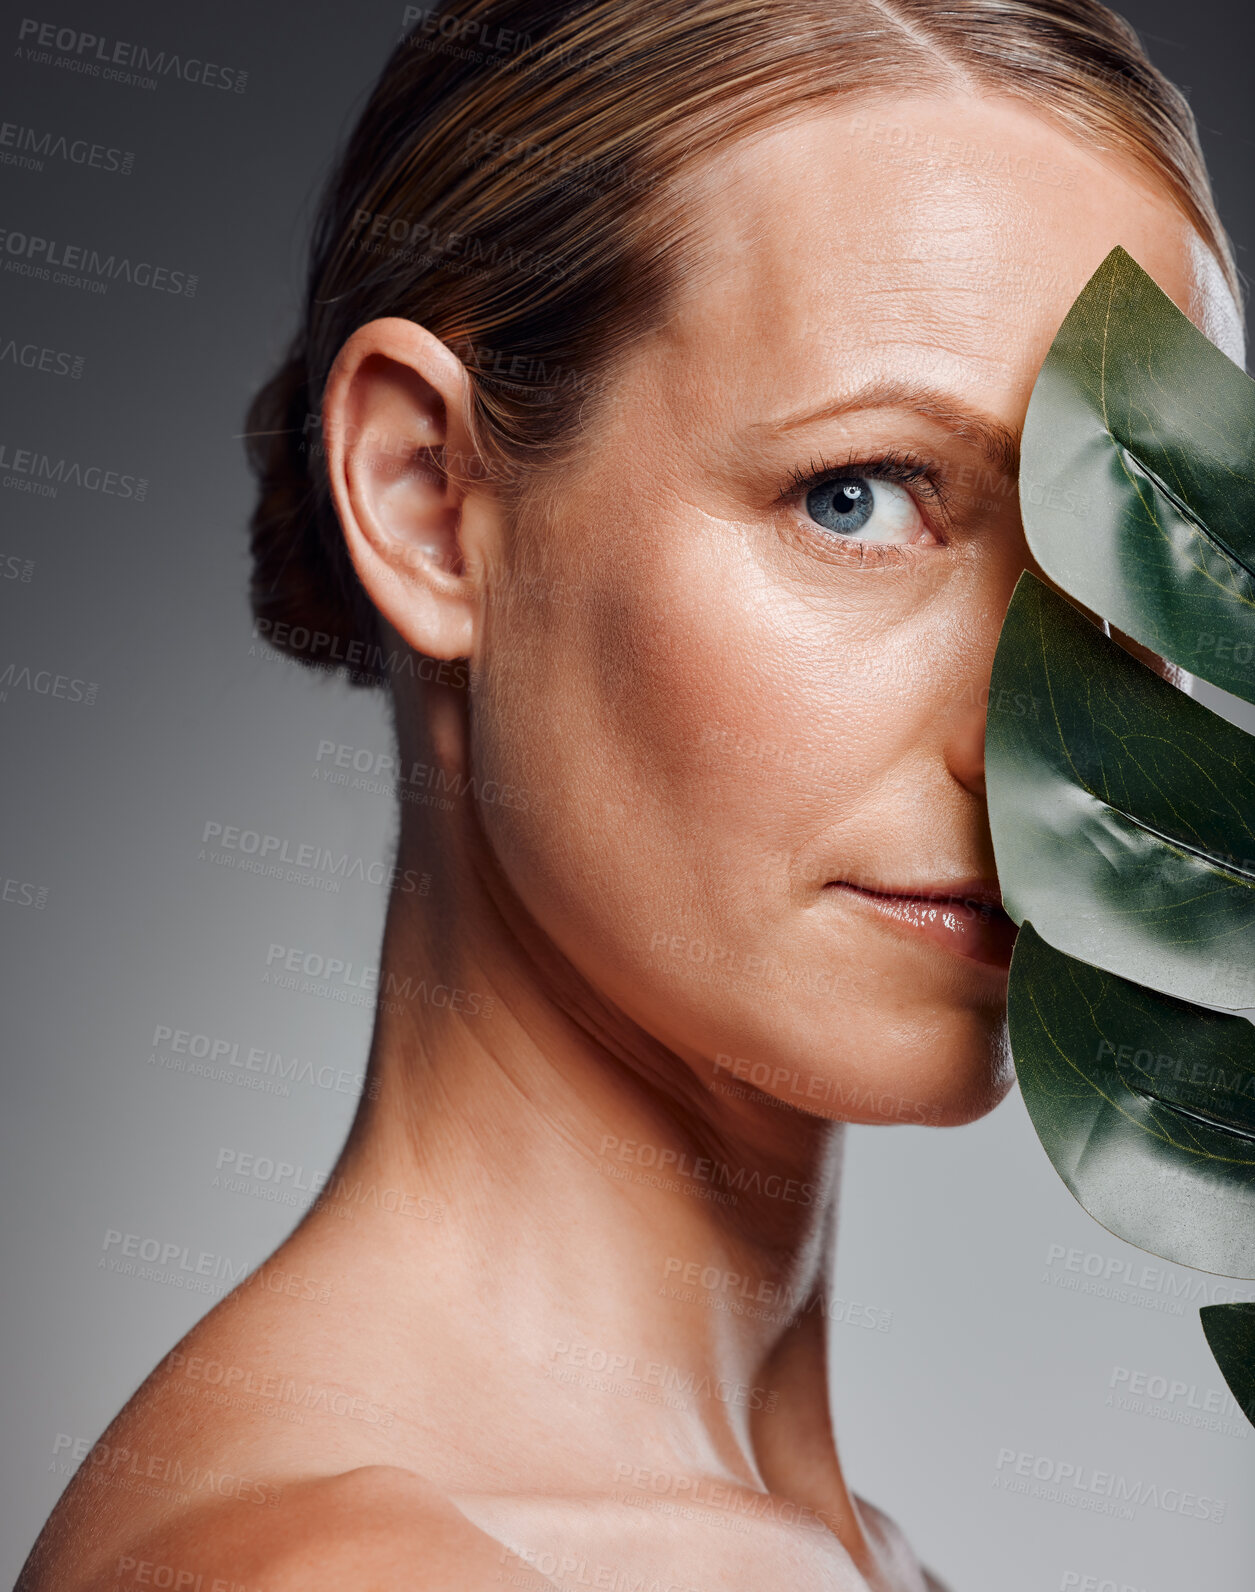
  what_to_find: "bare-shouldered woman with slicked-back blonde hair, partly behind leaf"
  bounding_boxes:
[21,0,1241,1592]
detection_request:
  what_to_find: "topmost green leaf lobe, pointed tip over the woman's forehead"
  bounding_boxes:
[1019,248,1255,702]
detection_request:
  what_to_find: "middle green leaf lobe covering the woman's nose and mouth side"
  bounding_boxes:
[986,573,1255,1008]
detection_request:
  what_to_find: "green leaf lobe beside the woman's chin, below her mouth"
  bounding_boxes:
[1007,923,1255,1279]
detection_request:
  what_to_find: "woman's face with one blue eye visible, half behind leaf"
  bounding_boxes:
[471,99,1239,1122]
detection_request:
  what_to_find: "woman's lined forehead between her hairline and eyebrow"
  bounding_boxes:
[663,97,1241,406]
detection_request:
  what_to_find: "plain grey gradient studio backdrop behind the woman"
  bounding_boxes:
[0,0,1255,1592]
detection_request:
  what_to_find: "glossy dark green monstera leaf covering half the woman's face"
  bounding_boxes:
[986,248,1255,1414]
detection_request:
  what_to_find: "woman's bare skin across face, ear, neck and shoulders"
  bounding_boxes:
[19,97,1241,1592]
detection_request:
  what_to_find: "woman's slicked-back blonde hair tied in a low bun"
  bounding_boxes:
[247,0,1241,685]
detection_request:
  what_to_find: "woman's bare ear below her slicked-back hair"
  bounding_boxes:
[322,317,487,659]
